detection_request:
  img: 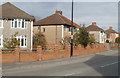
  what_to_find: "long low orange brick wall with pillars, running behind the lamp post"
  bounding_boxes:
[0,44,117,63]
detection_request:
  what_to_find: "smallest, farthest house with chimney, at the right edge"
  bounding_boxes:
[105,27,119,42]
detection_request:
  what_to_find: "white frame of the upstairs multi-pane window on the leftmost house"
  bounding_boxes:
[11,19,27,29]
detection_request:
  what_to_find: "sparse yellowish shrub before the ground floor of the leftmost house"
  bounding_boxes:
[3,32,20,49]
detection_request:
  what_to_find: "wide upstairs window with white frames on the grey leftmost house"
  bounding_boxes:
[12,19,26,29]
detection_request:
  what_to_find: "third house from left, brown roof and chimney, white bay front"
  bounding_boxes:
[86,22,106,43]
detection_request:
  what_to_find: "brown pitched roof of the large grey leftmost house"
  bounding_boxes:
[0,2,35,20]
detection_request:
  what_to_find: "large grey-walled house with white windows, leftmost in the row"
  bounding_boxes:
[0,2,35,49]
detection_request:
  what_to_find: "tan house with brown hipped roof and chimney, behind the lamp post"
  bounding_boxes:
[34,10,81,44]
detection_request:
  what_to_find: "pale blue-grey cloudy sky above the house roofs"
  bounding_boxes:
[0,0,118,31]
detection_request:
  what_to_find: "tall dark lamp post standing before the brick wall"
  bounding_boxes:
[70,0,73,57]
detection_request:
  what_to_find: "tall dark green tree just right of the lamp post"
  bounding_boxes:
[78,27,89,48]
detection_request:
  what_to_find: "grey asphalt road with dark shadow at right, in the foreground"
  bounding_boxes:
[2,50,120,76]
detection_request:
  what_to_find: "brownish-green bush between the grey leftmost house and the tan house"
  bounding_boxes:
[33,31,47,48]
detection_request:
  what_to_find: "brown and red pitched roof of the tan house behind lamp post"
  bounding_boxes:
[34,14,81,28]
